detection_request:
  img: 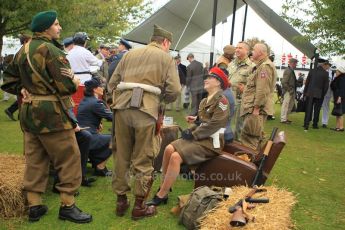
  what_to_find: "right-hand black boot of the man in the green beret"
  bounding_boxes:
[59,204,92,224]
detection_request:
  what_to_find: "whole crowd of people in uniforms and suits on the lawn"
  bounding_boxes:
[1,11,345,223]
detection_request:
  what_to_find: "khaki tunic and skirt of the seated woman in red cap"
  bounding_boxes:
[171,91,230,165]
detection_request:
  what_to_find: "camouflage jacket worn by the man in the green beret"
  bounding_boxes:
[1,33,77,134]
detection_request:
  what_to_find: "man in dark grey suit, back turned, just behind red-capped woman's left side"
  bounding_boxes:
[186,53,204,116]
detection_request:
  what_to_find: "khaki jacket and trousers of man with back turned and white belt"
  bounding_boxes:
[109,43,181,197]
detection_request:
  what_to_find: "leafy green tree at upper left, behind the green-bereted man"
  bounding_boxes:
[0,0,151,53]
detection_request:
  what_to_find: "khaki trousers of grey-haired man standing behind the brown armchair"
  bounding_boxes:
[241,114,267,150]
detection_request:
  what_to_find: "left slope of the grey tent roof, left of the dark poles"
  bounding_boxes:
[124,0,244,50]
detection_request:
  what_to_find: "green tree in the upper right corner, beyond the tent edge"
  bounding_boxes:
[282,0,345,55]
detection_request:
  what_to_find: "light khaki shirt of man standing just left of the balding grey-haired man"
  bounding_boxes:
[228,57,255,103]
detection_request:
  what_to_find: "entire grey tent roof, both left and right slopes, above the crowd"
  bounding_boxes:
[124,0,316,58]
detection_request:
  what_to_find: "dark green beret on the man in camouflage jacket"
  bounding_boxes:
[31,10,57,32]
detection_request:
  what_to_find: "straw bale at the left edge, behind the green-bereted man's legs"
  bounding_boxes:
[0,154,25,218]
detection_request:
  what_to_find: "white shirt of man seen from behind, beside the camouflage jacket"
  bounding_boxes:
[66,45,103,84]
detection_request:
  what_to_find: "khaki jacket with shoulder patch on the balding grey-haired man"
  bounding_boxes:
[240,58,276,116]
